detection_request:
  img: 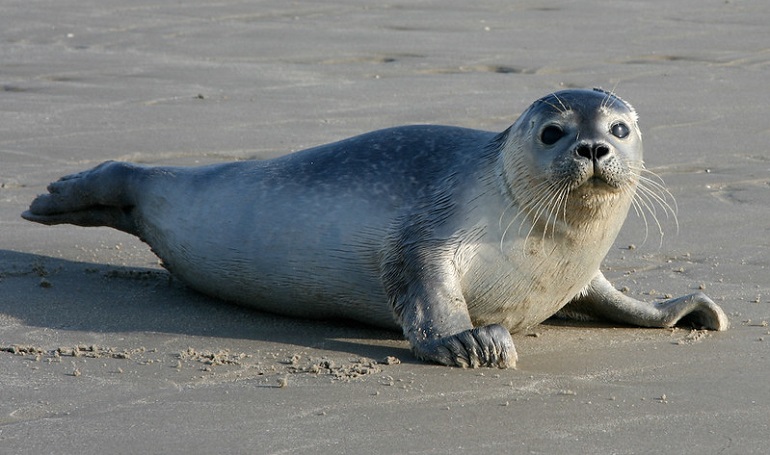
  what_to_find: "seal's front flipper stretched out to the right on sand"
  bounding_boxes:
[557,272,730,330]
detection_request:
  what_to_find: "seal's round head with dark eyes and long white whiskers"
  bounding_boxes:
[502,89,643,233]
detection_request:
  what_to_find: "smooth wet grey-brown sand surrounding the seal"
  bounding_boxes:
[0,0,770,454]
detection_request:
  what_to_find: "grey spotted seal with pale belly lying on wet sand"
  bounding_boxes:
[22,89,728,367]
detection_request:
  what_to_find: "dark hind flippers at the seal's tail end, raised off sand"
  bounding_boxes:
[21,162,136,234]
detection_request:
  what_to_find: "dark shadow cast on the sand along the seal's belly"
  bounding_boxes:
[0,250,413,361]
